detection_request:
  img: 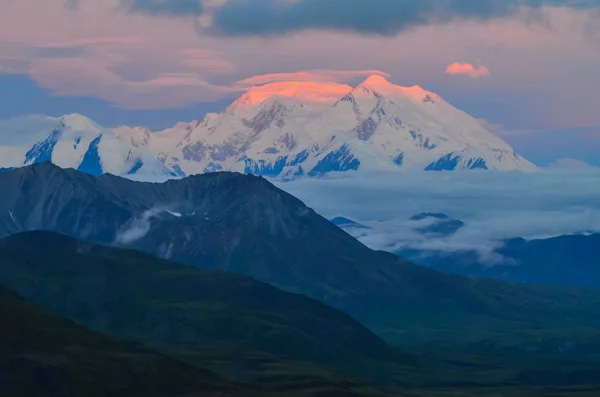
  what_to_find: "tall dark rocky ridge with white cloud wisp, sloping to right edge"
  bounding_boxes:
[0,164,600,352]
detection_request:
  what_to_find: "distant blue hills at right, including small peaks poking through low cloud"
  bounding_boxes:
[331,213,600,288]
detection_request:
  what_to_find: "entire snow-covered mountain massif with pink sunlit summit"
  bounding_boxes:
[0,75,536,178]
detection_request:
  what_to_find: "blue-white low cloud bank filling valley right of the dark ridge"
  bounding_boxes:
[278,169,600,265]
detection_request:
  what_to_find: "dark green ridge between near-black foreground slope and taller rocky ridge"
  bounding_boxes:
[0,232,414,386]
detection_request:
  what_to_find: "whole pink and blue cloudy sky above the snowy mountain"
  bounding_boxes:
[0,0,600,164]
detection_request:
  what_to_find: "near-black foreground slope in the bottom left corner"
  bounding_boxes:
[0,288,241,397]
